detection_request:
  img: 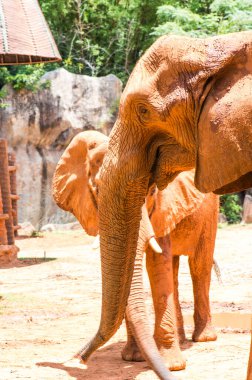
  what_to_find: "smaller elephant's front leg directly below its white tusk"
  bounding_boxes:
[146,236,186,370]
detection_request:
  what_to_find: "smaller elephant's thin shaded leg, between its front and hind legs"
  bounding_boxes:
[172,256,186,343]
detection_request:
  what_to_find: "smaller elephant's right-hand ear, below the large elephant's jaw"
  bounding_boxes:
[150,170,206,237]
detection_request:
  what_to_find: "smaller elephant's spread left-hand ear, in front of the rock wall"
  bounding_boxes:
[53,131,107,236]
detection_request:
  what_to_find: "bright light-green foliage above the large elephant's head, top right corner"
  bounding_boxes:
[151,0,252,37]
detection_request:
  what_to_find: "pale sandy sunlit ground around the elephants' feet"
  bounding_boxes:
[0,226,252,380]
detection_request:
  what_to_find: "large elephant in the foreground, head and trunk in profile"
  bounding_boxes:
[56,31,252,379]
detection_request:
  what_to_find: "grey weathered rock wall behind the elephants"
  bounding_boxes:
[0,68,122,229]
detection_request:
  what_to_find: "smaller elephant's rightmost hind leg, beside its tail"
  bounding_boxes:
[189,235,217,342]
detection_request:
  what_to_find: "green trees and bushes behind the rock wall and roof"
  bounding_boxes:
[0,0,252,221]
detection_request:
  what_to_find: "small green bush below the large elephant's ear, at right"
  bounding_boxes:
[220,194,242,223]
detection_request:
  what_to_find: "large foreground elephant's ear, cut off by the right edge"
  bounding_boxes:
[195,32,252,194]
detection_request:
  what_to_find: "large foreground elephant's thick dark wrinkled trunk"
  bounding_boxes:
[76,177,148,362]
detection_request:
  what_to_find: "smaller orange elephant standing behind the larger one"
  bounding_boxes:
[53,131,219,370]
